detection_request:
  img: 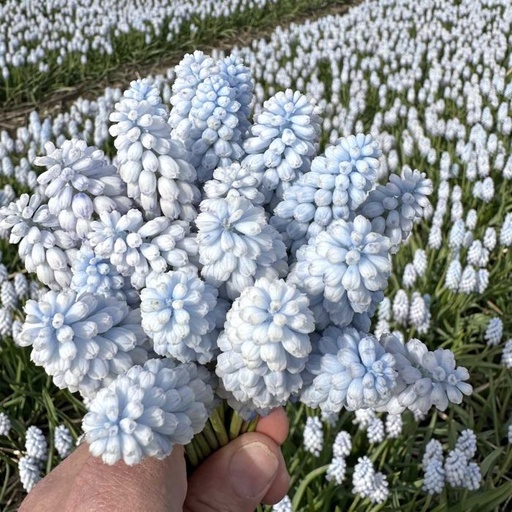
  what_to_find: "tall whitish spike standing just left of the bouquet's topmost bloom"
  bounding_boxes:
[109,79,201,221]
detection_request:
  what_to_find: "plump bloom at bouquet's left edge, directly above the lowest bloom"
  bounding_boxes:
[17,290,147,397]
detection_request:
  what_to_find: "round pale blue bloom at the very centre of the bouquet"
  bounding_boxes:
[196,192,288,300]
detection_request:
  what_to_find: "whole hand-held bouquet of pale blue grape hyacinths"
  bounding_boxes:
[0,52,472,466]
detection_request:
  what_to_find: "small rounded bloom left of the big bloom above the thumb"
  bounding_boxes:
[140,271,217,364]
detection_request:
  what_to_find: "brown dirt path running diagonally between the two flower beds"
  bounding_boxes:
[0,0,361,134]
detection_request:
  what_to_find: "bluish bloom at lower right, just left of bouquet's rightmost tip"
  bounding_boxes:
[301,327,398,412]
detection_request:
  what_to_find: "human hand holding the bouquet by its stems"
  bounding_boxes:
[19,409,289,512]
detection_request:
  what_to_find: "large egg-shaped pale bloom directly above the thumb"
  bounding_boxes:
[216,278,314,409]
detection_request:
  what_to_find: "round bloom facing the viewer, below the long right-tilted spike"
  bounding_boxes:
[289,216,391,326]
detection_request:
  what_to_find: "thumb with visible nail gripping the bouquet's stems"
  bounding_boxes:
[183,432,288,512]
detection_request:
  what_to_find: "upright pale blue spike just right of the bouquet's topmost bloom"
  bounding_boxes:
[242,89,321,204]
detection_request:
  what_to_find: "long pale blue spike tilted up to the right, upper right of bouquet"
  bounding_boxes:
[271,134,381,253]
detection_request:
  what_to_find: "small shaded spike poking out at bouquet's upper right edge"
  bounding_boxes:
[358,167,433,252]
